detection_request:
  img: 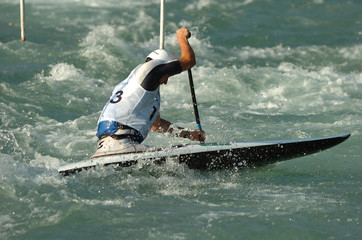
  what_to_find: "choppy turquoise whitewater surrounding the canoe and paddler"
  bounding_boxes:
[0,0,362,240]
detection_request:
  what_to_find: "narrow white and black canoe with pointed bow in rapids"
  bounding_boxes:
[58,134,350,176]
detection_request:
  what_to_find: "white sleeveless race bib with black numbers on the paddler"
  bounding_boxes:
[98,60,165,139]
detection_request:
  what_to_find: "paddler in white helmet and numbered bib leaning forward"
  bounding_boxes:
[92,28,205,157]
